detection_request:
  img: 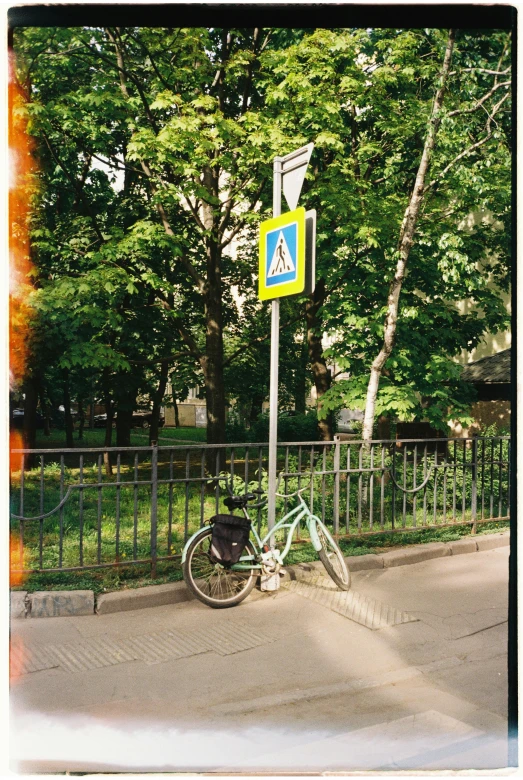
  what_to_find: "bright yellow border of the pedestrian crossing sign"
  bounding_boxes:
[258,206,305,301]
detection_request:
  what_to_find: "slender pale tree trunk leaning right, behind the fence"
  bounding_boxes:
[363,30,455,446]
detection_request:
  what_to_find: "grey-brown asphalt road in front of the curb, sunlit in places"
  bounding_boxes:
[10,547,508,773]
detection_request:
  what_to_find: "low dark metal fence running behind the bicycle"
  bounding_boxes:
[11,436,511,576]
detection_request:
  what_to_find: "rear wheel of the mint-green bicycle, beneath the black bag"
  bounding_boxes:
[183,528,258,609]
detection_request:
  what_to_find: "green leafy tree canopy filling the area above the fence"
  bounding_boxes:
[14,27,511,438]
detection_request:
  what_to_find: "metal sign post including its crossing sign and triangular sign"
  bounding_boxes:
[259,143,314,546]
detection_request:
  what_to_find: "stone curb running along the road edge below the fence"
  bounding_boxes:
[10,531,510,619]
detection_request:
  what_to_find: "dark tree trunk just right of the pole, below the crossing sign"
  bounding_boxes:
[305,278,333,441]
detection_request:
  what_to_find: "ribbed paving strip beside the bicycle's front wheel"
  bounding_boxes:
[282,573,418,631]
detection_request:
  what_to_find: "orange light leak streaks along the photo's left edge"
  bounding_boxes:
[8,41,37,585]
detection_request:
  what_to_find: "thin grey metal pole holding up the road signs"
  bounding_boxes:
[267,157,282,546]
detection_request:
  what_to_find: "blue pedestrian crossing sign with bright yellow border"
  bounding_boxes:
[258,208,305,301]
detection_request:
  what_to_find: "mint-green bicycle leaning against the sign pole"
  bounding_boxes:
[182,474,351,609]
